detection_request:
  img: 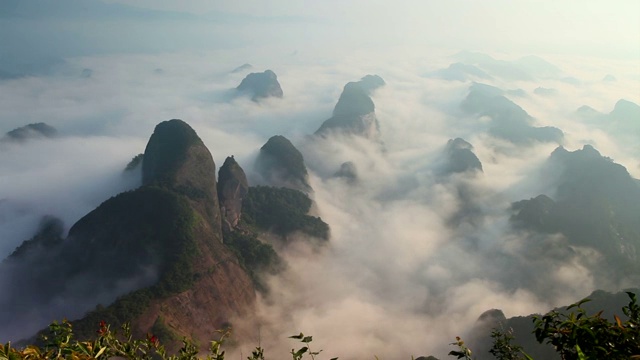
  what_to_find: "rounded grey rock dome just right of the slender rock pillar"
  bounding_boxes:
[255,135,312,193]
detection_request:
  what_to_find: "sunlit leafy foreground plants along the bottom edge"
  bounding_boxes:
[7,292,640,360]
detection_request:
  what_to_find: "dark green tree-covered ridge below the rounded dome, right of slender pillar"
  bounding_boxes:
[242,186,329,240]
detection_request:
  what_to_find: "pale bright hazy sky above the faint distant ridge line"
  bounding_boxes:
[101,0,640,58]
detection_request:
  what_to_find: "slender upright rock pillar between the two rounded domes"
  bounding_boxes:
[218,156,249,231]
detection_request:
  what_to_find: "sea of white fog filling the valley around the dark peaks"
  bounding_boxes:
[0,47,640,358]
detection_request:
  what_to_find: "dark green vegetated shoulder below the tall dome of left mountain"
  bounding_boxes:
[64,186,199,338]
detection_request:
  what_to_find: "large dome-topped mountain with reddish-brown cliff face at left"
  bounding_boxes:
[0,120,255,346]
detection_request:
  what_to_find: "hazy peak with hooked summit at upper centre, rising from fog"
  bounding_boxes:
[315,75,385,141]
